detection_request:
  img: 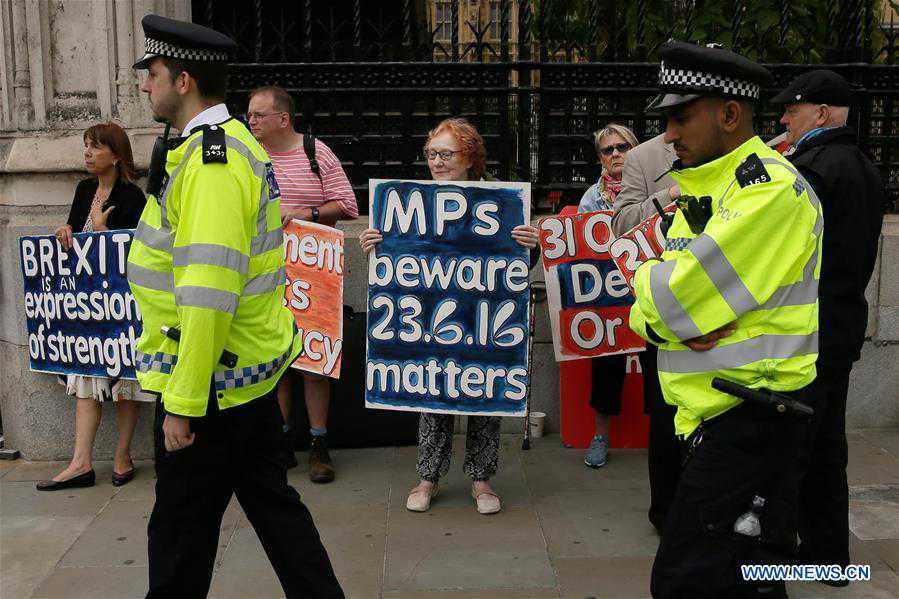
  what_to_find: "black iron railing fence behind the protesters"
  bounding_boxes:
[193,0,899,210]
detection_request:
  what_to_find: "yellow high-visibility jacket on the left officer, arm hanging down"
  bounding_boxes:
[128,119,301,416]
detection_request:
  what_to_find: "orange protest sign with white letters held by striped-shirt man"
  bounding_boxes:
[284,220,343,378]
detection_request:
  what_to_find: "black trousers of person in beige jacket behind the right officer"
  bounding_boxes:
[640,350,681,530]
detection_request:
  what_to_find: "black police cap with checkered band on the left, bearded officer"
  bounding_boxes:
[133,15,237,69]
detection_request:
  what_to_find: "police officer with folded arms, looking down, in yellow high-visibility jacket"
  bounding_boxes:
[630,42,823,598]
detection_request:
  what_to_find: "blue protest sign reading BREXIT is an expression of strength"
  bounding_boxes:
[19,231,142,379]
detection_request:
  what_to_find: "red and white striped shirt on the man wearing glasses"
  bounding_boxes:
[266,139,359,218]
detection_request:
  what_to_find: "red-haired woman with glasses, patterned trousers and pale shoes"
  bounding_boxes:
[359,118,539,514]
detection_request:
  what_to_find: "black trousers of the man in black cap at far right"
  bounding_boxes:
[799,364,852,566]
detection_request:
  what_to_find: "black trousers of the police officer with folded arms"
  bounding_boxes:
[651,383,818,599]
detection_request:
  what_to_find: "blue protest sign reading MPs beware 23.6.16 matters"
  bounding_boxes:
[365,180,530,416]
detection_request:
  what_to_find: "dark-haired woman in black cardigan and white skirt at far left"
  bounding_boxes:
[37,123,154,491]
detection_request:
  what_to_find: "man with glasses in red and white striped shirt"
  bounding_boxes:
[247,86,359,483]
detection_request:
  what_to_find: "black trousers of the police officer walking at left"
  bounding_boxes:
[147,386,344,599]
